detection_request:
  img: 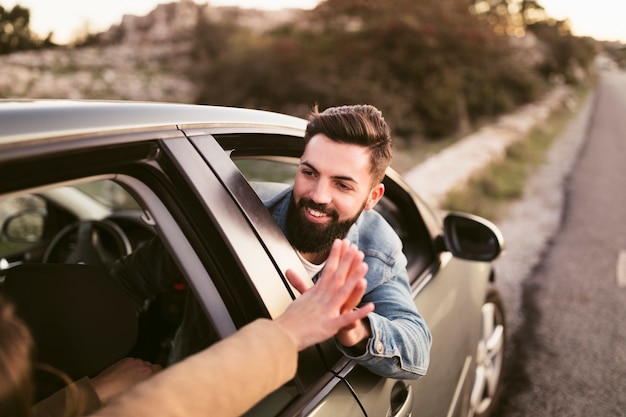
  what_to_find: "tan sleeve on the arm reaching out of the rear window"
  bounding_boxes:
[91,319,298,417]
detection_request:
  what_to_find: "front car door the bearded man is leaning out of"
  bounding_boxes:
[204,131,490,416]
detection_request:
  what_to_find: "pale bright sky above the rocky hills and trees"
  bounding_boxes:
[0,0,626,43]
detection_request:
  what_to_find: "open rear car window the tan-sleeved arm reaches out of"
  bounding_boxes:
[0,171,233,408]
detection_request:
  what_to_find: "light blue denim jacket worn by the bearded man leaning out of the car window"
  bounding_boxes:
[255,185,432,379]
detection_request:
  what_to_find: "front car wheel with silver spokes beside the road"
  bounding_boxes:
[469,285,506,417]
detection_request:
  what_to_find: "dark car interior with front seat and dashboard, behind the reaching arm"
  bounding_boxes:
[0,180,190,399]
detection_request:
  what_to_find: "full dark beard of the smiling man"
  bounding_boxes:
[286,195,365,253]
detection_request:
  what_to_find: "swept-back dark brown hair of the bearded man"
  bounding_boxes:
[304,104,393,183]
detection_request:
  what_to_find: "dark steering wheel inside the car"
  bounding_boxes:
[43,220,132,268]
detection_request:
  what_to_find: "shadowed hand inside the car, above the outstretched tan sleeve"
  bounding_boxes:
[91,358,161,404]
